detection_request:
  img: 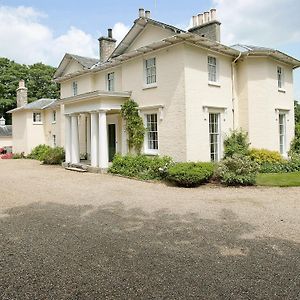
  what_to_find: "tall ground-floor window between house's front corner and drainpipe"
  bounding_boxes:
[209,113,220,161]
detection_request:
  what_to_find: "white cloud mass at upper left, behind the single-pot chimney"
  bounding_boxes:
[0,5,129,66]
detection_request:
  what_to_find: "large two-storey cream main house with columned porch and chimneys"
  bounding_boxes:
[8,9,300,169]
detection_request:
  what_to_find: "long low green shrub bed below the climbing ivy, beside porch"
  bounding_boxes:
[108,154,173,180]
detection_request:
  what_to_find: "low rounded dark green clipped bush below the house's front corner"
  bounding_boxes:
[167,162,215,187]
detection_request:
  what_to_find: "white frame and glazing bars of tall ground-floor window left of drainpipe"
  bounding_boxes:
[208,111,222,162]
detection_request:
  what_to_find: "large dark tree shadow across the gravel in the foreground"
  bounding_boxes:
[0,203,300,300]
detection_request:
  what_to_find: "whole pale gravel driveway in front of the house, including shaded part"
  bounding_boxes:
[0,160,300,300]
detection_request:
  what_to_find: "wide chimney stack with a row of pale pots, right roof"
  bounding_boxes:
[189,8,221,42]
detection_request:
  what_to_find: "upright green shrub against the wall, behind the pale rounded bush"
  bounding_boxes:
[224,130,250,158]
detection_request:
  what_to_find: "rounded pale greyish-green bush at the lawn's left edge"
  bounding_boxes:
[216,154,259,186]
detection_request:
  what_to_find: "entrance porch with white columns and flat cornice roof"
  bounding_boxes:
[61,91,130,172]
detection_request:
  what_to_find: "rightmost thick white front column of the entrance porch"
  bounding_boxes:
[99,111,108,169]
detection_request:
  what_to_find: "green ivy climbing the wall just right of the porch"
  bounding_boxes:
[121,99,146,153]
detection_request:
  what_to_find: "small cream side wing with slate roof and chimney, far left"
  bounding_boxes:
[8,80,61,155]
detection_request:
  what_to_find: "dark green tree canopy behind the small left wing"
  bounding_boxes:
[0,57,59,124]
